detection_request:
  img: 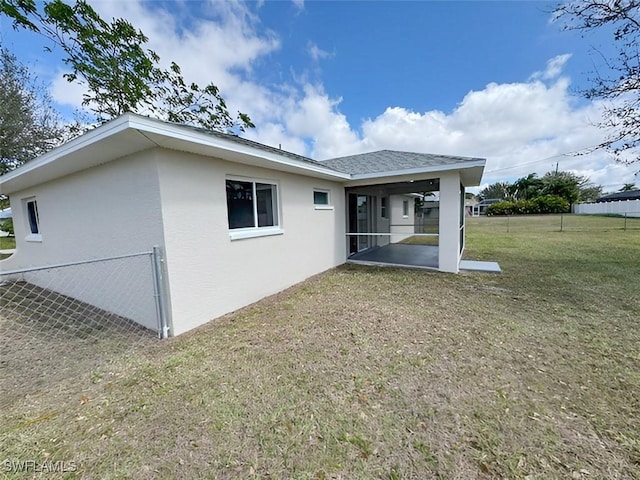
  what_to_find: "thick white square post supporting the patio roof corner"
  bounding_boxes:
[438,171,460,273]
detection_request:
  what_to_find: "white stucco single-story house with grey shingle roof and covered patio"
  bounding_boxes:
[0,114,485,335]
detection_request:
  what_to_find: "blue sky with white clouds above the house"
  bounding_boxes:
[0,0,638,190]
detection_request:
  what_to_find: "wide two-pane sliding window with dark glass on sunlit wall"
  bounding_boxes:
[226,180,279,230]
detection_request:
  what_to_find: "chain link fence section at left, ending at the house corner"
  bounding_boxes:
[0,249,166,409]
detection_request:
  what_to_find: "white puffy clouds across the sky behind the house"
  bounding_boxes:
[47,1,637,193]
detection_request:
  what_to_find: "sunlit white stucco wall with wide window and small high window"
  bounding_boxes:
[158,150,346,335]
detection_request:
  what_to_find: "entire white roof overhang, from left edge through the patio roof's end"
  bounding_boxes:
[0,113,485,194]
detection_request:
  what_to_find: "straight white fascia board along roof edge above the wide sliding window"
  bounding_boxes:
[125,116,351,181]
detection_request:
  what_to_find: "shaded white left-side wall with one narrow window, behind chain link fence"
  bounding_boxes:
[0,152,163,329]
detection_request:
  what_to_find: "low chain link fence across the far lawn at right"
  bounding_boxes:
[466,212,640,233]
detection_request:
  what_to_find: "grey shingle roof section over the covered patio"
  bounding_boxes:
[320,150,484,175]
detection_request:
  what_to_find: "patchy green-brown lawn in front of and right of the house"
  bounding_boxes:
[0,217,640,480]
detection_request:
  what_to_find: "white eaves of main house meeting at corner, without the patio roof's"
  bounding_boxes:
[0,113,351,194]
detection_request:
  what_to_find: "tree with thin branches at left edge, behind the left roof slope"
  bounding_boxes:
[0,48,65,175]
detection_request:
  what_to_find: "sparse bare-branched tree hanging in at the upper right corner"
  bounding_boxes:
[555,0,640,163]
